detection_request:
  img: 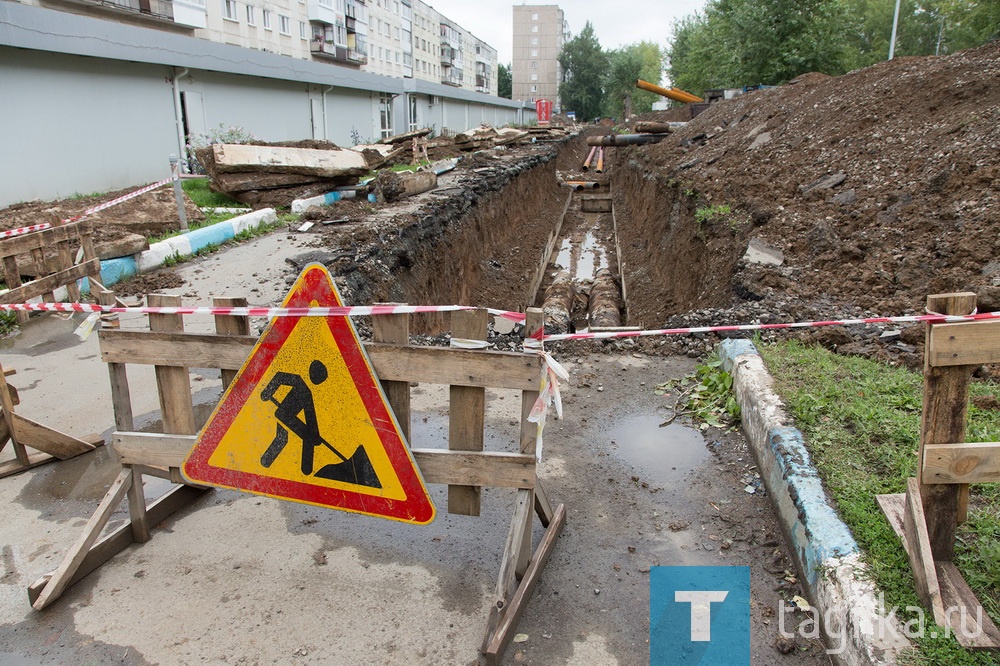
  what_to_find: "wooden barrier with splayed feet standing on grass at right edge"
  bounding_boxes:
[878,293,1000,650]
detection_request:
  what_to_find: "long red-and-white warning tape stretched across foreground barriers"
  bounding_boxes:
[0,303,1000,346]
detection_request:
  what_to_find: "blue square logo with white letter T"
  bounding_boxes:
[649,567,750,666]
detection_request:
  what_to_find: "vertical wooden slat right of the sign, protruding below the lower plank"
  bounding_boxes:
[448,308,489,516]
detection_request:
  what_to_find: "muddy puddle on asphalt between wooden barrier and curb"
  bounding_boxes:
[604,412,709,487]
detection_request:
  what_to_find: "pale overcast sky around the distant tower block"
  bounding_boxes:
[426,0,705,64]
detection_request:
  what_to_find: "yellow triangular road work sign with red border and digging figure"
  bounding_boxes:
[183,264,434,525]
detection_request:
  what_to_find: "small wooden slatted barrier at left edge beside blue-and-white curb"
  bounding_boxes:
[0,220,101,324]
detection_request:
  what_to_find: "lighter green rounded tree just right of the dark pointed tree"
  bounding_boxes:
[604,42,662,118]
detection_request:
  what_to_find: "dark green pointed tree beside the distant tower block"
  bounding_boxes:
[559,21,608,120]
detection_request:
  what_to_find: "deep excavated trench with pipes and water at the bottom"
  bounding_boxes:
[334,128,740,332]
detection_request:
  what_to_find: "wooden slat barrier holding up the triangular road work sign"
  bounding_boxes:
[28,296,566,663]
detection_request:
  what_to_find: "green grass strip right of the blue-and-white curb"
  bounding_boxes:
[758,341,1000,666]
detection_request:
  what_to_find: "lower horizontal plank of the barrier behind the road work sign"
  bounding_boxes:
[111,432,537,489]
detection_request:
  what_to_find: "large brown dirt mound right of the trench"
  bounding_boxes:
[636,43,1000,315]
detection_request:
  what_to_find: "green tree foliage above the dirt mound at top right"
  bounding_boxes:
[667,0,1000,94]
